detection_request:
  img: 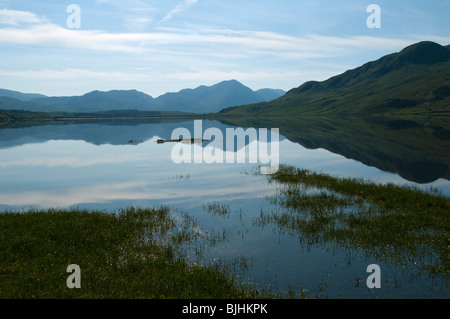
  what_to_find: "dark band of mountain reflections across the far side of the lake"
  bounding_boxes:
[0,117,450,184]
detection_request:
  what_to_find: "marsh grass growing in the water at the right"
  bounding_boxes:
[255,166,450,278]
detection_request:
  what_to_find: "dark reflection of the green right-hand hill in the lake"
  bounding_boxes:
[221,117,450,183]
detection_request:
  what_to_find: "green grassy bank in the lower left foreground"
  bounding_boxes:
[0,208,264,299]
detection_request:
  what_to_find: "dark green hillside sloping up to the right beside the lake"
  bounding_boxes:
[220,41,450,116]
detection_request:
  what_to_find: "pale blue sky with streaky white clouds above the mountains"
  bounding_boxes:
[0,0,450,97]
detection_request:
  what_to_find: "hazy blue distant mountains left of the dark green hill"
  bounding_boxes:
[0,80,286,113]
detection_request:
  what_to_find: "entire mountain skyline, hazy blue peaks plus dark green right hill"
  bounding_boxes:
[0,41,450,117]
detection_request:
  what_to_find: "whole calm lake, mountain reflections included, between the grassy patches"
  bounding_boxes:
[0,118,450,298]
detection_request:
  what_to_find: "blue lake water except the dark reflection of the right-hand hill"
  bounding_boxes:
[0,121,450,298]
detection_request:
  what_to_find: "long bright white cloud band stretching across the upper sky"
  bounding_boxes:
[0,13,413,60]
